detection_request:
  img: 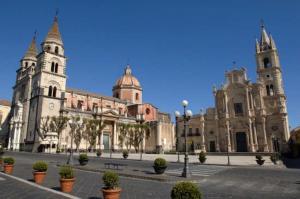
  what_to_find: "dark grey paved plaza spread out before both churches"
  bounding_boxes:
[0,152,300,199]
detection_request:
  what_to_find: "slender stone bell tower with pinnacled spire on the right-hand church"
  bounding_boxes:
[255,23,289,151]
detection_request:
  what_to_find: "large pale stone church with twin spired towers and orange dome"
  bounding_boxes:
[8,17,175,152]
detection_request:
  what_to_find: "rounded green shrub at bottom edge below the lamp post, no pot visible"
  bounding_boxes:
[171,182,202,199]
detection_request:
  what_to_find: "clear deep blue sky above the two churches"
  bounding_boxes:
[0,0,300,127]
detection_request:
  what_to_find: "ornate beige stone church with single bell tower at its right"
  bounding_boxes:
[176,25,289,152]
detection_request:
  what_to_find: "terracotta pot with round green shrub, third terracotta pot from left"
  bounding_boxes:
[59,165,75,193]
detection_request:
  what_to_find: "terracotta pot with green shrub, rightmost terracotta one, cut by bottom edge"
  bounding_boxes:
[102,171,122,199]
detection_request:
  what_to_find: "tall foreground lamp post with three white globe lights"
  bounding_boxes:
[175,100,193,178]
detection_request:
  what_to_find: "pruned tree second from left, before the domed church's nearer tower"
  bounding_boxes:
[51,115,69,151]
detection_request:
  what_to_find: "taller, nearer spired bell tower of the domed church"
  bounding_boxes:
[26,16,66,151]
